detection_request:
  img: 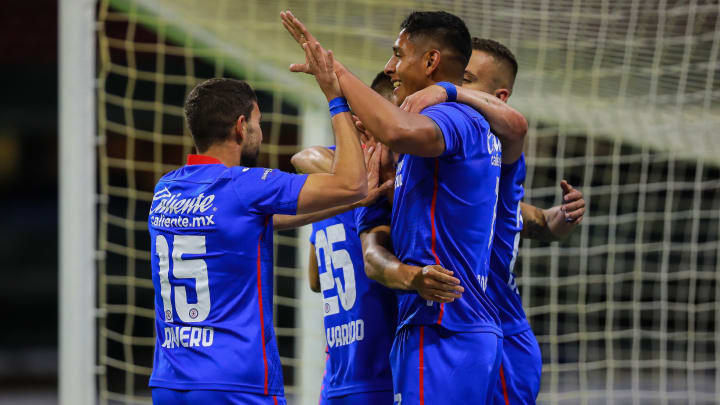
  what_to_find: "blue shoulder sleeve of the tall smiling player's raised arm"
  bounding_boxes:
[421,103,490,157]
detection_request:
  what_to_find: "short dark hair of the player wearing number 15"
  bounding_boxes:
[185,78,257,153]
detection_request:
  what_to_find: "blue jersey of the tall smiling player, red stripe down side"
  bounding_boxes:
[391,103,502,336]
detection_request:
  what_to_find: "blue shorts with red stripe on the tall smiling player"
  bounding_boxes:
[390,325,503,405]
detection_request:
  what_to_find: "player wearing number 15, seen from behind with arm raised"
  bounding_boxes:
[148,39,367,405]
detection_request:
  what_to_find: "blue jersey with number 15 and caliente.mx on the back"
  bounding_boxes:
[149,155,307,395]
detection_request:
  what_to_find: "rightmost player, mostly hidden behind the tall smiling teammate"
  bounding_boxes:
[403,38,585,405]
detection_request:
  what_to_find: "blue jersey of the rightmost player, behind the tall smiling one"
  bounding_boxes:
[488,156,530,336]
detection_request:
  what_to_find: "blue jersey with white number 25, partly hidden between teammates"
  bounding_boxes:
[310,211,397,398]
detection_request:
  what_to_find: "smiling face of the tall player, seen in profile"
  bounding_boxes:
[385,30,432,105]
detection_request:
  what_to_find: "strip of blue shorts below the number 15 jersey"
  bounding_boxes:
[152,388,287,405]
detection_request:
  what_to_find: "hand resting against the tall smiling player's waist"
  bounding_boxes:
[404,265,465,303]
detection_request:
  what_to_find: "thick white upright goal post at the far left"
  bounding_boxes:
[58,0,97,405]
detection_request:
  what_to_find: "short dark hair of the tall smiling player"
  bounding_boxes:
[400,11,472,78]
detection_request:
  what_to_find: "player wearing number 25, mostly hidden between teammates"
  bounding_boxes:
[291,72,397,405]
